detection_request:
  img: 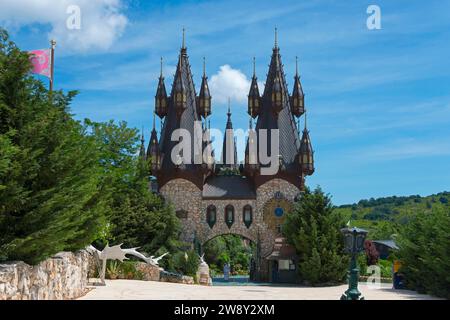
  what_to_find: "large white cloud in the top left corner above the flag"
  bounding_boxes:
[0,0,128,52]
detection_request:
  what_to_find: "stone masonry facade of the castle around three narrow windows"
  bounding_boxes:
[160,179,300,257]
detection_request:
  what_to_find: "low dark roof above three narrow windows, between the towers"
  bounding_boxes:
[203,176,256,199]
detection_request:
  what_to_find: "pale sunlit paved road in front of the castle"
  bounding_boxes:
[81,280,442,300]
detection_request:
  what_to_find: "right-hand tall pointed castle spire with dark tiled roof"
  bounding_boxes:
[246,31,313,187]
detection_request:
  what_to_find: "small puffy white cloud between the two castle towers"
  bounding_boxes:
[209,64,250,103]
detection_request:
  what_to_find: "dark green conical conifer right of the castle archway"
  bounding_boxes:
[283,188,349,285]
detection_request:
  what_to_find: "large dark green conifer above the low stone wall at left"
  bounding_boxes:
[0,30,107,264]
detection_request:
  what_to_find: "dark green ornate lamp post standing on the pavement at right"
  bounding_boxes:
[341,228,367,300]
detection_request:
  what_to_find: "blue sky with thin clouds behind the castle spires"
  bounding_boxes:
[0,0,450,204]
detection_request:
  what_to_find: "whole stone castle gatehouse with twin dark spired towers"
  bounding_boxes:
[141,31,314,281]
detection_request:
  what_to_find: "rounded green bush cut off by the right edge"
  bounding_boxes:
[397,208,450,299]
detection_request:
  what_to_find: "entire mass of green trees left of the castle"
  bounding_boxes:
[0,30,183,266]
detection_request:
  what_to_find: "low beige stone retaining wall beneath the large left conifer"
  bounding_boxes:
[0,250,91,300]
